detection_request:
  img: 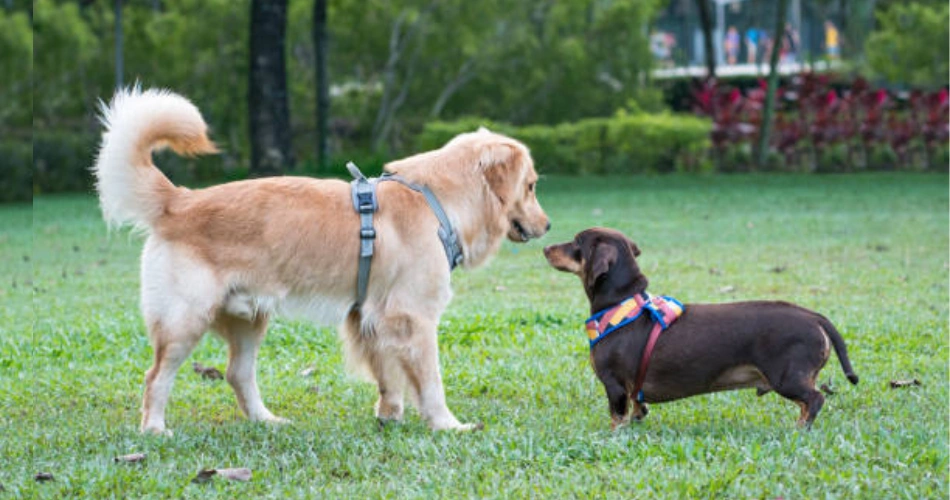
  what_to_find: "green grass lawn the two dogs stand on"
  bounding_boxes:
[0,174,950,499]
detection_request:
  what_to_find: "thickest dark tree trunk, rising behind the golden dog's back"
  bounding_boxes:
[248,0,293,177]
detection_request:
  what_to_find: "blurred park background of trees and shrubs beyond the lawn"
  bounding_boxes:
[9,0,950,200]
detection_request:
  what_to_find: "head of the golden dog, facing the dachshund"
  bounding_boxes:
[460,128,551,243]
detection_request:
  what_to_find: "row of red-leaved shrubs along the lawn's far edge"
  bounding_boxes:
[692,73,950,170]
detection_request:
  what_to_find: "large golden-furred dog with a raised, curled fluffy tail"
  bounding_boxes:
[93,89,550,433]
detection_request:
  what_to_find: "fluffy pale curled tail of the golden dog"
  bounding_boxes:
[92,86,217,230]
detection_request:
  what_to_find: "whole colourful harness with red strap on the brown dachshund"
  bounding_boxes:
[586,292,686,403]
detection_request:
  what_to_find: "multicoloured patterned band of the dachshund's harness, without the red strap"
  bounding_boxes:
[585,292,685,349]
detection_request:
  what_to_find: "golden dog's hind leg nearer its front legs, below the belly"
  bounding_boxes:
[214,314,288,423]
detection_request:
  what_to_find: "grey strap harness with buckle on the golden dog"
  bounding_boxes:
[346,162,463,309]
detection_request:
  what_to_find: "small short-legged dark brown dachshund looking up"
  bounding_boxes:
[544,228,858,429]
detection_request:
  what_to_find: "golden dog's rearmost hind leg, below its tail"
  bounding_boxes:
[141,321,204,435]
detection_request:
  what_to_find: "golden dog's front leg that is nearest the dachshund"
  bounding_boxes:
[402,319,483,431]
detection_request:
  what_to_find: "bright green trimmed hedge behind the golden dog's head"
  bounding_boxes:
[416,113,712,175]
